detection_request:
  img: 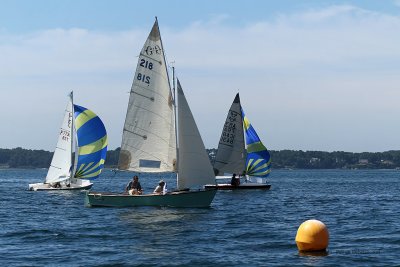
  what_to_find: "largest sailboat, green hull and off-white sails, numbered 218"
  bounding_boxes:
[85,18,216,207]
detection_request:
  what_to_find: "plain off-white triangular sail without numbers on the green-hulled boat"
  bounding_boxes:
[177,80,215,189]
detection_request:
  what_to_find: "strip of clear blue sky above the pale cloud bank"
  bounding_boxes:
[0,0,399,33]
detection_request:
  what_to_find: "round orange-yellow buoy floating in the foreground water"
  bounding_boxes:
[296,220,329,251]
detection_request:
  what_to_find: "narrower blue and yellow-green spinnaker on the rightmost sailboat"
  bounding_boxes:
[241,108,271,177]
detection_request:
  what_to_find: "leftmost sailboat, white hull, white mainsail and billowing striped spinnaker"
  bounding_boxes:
[28,92,107,191]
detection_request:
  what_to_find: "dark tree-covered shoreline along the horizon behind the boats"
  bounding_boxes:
[0,147,400,169]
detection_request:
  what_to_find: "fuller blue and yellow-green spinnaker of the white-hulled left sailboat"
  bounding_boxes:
[74,105,108,179]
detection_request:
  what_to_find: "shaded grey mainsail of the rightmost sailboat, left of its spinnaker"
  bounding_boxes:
[214,94,246,175]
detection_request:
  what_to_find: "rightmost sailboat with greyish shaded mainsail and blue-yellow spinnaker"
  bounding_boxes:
[205,93,271,190]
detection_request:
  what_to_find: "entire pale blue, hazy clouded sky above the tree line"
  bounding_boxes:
[0,0,400,152]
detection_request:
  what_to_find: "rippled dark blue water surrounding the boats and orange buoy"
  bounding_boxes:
[0,170,400,266]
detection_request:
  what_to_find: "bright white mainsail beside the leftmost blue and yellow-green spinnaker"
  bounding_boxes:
[45,94,73,183]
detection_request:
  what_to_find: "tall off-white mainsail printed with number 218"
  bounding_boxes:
[118,20,176,172]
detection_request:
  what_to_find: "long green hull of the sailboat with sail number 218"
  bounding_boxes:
[85,189,217,208]
